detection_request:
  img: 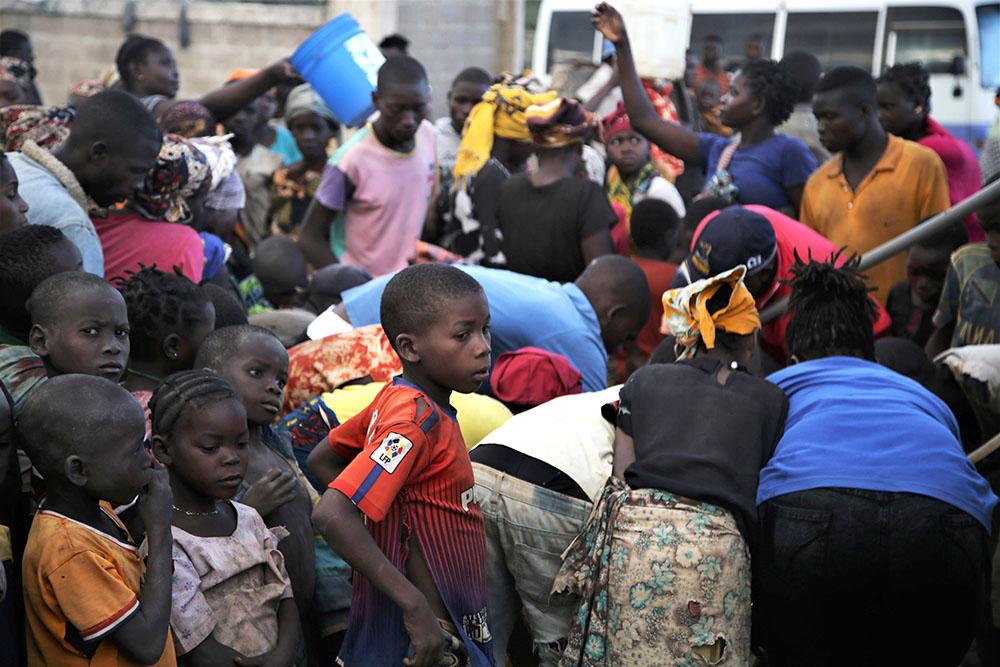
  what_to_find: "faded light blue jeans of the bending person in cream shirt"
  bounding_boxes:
[472,463,593,667]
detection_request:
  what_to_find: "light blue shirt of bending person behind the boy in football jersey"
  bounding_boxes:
[344,265,608,391]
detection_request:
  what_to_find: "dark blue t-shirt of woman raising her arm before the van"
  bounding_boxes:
[698,132,816,211]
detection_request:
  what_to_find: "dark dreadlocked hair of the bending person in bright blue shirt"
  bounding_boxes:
[784,251,877,360]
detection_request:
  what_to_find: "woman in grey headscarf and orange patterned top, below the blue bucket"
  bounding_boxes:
[267,83,340,238]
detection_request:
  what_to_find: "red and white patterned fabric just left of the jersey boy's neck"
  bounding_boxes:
[281,324,403,415]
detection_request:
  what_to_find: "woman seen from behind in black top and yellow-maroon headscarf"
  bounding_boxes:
[494,98,618,283]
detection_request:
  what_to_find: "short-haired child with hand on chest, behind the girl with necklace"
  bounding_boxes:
[195,325,315,618]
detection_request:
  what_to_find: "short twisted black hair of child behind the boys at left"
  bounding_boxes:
[114,264,209,362]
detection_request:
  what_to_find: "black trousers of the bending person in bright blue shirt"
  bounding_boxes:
[754,488,990,667]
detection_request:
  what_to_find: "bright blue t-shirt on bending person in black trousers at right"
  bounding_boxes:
[757,357,997,531]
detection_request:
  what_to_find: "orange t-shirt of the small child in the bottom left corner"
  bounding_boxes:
[22,507,177,667]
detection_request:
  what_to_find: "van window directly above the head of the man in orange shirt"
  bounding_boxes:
[784,12,878,72]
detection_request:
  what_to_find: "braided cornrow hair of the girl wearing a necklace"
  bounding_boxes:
[149,368,240,436]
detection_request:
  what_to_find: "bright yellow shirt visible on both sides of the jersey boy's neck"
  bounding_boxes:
[323,382,513,449]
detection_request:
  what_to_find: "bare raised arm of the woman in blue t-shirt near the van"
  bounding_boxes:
[592,2,700,162]
